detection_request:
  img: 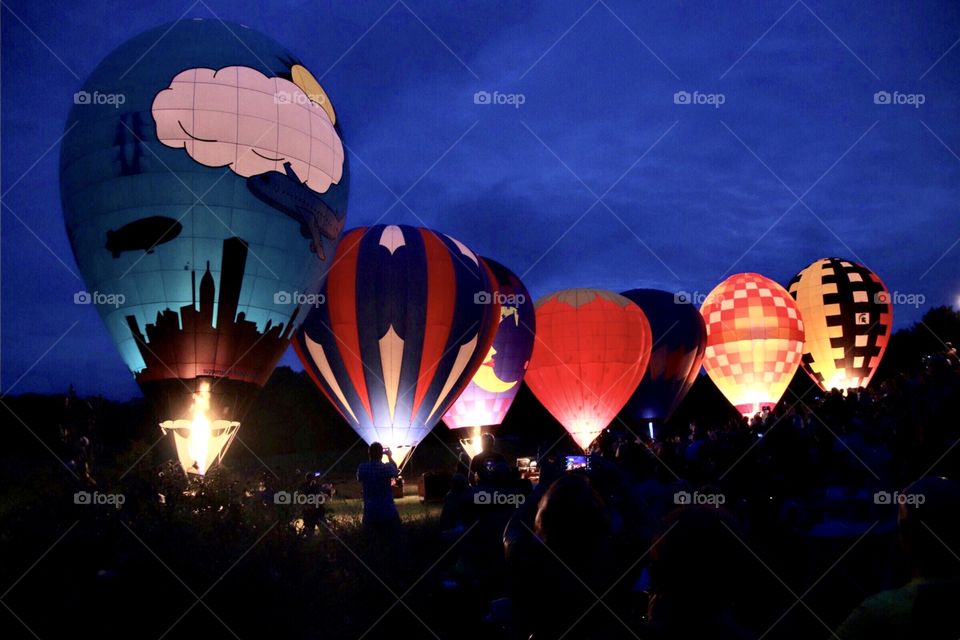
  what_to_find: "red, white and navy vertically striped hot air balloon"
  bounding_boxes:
[294,225,500,464]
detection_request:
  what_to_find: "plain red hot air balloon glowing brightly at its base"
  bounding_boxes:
[524,289,652,450]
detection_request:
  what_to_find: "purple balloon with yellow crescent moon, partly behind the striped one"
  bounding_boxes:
[443,258,536,454]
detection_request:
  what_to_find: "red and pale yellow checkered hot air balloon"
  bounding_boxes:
[700,273,803,415]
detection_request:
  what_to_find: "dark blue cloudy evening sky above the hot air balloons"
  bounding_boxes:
[0,0,960,398]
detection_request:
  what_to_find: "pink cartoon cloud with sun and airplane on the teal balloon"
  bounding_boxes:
[152,65,344,260]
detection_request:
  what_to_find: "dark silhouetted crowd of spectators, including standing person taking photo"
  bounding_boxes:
[357,349,960,640]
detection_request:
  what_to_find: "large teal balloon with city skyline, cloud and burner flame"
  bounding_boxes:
[60,20,349,473]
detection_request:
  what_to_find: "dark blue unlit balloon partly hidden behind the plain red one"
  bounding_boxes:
[621,289,707,422]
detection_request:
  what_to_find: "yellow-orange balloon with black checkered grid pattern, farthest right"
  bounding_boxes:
[787,258,893,391]
